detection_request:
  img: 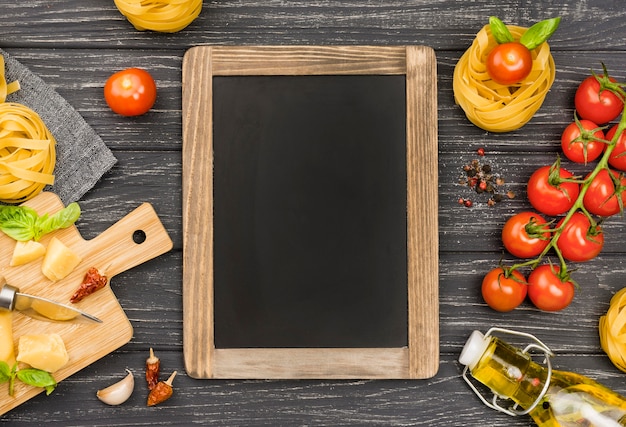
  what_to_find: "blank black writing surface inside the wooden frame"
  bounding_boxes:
[213,75,408,348]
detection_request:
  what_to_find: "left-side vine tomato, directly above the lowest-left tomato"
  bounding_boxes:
[502,212,550,258]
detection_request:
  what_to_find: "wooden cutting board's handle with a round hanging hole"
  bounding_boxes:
[85,203,173,278]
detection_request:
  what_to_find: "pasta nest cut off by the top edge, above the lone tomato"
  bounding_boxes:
[115,0,202,33]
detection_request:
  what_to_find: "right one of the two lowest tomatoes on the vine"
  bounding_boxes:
[528,264,574,311]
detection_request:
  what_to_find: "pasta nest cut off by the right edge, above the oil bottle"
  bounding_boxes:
[599,288,626,372]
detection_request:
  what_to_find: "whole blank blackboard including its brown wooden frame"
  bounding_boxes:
[183,46,438,378]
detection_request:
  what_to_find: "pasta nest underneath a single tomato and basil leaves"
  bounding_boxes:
[452,25,556,132]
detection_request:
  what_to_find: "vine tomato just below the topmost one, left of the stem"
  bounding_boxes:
[561,119,605,163]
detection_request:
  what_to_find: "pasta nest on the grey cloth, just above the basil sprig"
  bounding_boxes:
[0,102,56,203]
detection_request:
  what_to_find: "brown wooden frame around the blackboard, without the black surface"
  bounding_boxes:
[182,46,439,379]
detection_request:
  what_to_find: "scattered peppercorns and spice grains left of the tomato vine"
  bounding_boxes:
[459,147,515,208]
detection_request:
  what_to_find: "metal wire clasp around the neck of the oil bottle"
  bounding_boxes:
[462,327,554,416]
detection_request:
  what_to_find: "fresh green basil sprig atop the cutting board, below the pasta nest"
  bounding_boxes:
[0,202,80,241]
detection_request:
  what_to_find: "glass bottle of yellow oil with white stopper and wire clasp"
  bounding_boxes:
[459,328,626,427]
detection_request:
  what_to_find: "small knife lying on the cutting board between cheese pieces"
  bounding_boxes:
[0,284,102,323]
